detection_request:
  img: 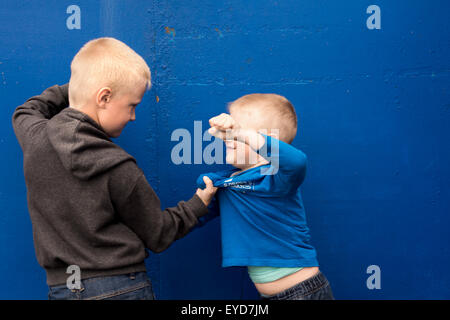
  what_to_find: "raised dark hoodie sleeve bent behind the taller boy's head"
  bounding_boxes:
[12,84,69,148]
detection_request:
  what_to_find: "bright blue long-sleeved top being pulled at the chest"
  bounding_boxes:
[197,135,319,267]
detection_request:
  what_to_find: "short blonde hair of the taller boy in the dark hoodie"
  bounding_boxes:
[69,38,151,106]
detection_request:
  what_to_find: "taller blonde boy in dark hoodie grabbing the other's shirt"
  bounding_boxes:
[12,38,215,299]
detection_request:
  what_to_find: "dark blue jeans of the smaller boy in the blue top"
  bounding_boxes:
[261,271,334,300]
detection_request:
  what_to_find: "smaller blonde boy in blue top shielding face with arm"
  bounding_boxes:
[198,94,333,300]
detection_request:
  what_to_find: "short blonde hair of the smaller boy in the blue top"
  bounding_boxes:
[228,93,297,143]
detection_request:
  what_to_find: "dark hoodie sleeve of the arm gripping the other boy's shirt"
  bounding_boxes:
[109,162,208,252]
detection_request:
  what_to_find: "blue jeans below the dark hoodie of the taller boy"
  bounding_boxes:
[48,272,155,300]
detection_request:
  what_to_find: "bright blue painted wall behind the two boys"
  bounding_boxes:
[0,0,450,299]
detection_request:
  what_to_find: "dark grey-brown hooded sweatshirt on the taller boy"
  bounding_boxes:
[12,84,208,285]
